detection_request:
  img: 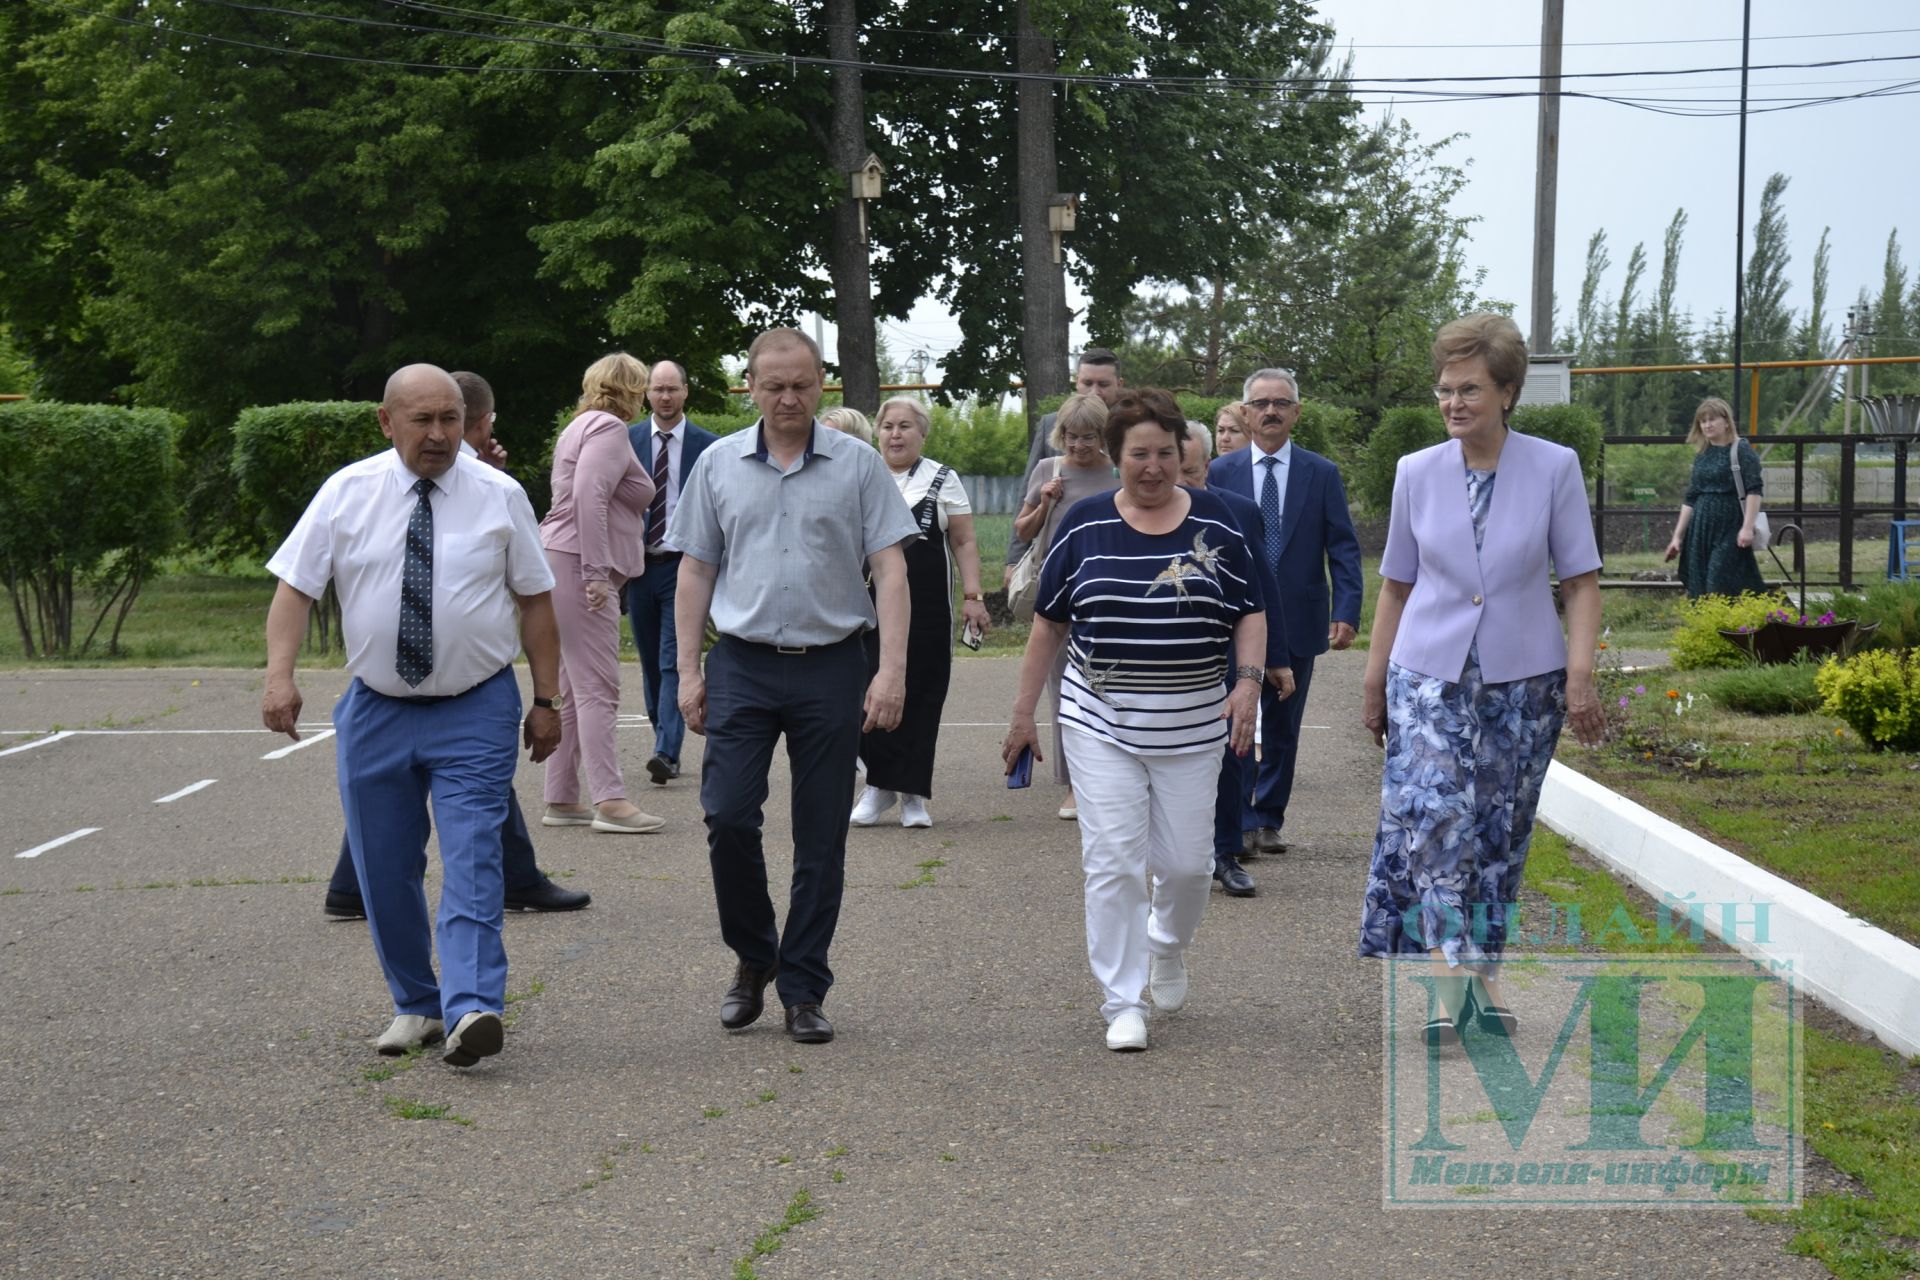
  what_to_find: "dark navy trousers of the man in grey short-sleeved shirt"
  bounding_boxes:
[701,635,868,1006]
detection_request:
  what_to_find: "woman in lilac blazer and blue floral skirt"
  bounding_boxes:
[1359,315,1605,1044]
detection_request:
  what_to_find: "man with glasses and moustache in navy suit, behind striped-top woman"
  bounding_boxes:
[1208,368,1361,856]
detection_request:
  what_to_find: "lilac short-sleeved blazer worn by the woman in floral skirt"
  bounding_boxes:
[1380,432,1599,683]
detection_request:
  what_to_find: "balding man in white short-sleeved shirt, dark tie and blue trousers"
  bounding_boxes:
[261,365,561,1067]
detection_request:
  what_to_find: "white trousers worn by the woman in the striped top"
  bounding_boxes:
[1064,727,1219,1023]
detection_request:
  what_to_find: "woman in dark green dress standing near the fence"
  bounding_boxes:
[1667,395,1766,599]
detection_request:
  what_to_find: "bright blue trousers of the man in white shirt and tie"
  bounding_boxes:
[334,668,520,1027]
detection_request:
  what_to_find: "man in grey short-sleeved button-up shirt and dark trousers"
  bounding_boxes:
[668,328,920,1044]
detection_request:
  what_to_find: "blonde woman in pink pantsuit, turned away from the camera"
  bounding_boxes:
[540,351,664,833]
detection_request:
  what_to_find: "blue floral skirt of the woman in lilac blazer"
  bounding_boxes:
[1359,658,1567,965]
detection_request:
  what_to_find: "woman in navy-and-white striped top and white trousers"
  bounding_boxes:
[1002,388,1267,1050]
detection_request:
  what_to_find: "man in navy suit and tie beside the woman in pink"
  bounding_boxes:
[624,361,718,787]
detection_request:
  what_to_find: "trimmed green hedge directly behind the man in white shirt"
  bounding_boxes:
[232,401,388,547]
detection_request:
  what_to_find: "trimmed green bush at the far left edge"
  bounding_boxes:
[0,401,180,658]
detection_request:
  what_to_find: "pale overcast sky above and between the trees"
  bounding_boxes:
[860,0,1920,387]
